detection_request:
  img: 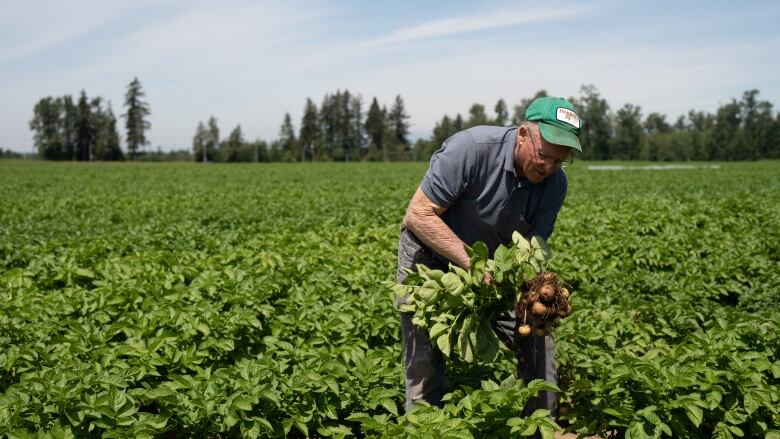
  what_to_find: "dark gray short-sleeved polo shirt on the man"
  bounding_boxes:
[420,126,567,255]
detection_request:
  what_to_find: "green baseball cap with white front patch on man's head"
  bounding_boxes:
[525,96,582,152]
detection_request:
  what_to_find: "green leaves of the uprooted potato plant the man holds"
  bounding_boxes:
[388,232,552,363]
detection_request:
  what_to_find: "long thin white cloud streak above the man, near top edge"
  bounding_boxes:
[365,5,587,46]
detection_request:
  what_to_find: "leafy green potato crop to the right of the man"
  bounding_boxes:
[554,163,780,437]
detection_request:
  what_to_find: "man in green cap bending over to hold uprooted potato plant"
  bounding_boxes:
[397,97,582,414]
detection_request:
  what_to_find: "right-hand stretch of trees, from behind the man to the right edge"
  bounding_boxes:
[414,85,780,161]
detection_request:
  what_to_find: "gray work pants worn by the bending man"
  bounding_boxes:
[396,229,558,417]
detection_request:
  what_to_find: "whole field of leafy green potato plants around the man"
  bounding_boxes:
[0,161,780,438]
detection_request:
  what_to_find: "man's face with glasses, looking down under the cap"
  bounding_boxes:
[515,125,571,183]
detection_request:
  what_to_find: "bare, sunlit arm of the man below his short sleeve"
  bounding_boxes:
[403,187,471,268]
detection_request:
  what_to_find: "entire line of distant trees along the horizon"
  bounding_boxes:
[22,78,780,162]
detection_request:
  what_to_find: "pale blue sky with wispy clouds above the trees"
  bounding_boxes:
[0,0,780,152]
